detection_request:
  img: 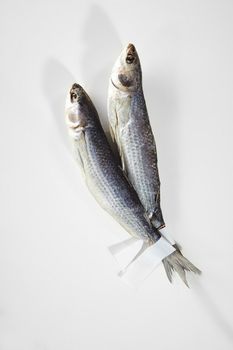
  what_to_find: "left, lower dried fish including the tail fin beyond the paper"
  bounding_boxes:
[65,83,198,285]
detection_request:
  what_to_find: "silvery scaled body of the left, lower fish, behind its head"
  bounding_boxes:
[68,98,160,241]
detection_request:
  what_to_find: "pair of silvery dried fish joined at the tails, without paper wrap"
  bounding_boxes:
[66,44,200,285]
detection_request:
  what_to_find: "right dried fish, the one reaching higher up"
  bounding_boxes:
[108,44,165,229]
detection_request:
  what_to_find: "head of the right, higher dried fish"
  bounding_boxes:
[111,44,142,92]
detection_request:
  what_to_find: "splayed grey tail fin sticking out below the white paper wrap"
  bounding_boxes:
[163,249,201,287]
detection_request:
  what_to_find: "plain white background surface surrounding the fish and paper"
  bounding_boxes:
[0,0,233,350]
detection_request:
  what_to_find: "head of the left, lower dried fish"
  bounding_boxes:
[65,83,93,135]
